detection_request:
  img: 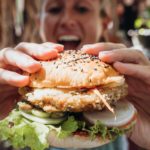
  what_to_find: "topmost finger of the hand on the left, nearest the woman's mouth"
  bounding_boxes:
[15,43,63,60]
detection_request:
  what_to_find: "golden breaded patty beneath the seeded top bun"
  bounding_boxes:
[21,84,127,112]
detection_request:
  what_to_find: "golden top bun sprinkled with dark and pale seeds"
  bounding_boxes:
[26,50,124,88]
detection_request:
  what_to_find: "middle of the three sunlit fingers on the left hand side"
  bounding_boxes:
[0,48,41,73]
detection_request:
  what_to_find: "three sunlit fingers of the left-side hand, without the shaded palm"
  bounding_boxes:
[0,43,63,87]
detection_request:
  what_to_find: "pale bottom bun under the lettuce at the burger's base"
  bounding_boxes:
[48,131,110,149]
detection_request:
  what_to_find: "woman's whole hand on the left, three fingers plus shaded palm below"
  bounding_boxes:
[0,43,63,119]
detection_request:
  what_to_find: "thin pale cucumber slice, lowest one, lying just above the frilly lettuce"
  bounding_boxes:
[20,111,66,125]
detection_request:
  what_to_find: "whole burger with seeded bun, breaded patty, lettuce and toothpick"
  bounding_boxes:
[0,50,136,150]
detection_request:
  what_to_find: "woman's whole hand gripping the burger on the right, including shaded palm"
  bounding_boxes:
[82,43,150,149]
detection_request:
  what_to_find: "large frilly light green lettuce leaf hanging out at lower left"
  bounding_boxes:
[0,111,50,150]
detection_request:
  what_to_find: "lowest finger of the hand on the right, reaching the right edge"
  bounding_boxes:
[113,62,150,84]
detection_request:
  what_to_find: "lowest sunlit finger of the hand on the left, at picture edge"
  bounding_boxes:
[0,68,29,87]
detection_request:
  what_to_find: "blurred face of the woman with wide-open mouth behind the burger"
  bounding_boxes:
[40,0,102,49]
